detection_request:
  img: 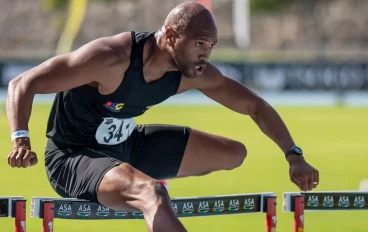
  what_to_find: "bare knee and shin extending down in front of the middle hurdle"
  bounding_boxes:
[97,163,187,232]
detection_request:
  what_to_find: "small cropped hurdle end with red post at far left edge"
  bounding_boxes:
[0,196,27,232]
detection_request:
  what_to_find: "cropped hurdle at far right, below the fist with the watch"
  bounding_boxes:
[282,191,368,232]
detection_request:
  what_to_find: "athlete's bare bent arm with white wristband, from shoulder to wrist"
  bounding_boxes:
[6,32,130,149]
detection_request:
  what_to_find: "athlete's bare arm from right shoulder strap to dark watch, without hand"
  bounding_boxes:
[189,64,295,159]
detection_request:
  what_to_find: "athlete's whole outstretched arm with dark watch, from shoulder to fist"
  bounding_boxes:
[193,63,319,190]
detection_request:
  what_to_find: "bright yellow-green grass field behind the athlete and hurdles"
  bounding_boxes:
[0,106,368,232]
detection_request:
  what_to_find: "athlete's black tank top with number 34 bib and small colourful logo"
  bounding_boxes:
[46,31,181,148]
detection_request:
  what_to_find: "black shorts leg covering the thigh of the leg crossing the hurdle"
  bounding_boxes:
[45,149,122,202]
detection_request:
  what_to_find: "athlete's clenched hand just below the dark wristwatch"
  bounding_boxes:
[288,155,319,191]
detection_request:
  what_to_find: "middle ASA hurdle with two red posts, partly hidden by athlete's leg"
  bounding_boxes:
[31,192,276,232]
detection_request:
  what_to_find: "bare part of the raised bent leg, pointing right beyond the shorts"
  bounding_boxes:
[177,129,247,177]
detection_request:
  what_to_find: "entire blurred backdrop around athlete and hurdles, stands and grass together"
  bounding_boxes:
[0,0,368,232]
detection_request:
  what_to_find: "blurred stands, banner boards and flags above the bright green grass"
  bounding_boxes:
[0,0,368,106]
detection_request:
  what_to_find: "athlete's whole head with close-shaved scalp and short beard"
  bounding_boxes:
[161,2,217,78]
